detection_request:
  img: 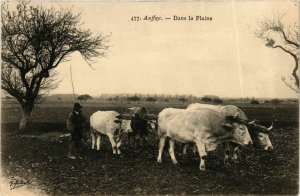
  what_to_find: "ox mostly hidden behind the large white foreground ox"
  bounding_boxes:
[183,103,273,164]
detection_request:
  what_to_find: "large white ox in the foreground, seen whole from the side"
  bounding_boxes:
[157,108,252,171]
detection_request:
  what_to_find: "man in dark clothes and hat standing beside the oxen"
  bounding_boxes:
[67,103,85,159]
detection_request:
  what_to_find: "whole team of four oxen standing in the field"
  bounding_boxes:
[90,103,273,171]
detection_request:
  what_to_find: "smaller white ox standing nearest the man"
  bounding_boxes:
[90,111,131,154]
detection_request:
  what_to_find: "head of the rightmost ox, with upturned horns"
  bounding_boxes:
[248,121,273,150]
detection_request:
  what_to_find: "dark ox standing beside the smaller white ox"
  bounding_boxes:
[116,107,157,145]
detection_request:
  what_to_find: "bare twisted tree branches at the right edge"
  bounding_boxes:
[255,15,300,96]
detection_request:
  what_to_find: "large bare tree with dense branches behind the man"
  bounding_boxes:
[1,1,108,130]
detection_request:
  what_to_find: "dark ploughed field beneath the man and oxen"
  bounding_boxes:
[1,101,299,195]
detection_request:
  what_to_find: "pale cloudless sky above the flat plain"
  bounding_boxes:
[17,1,299,98]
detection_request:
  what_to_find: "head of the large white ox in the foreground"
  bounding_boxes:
[222,114,253,146]
